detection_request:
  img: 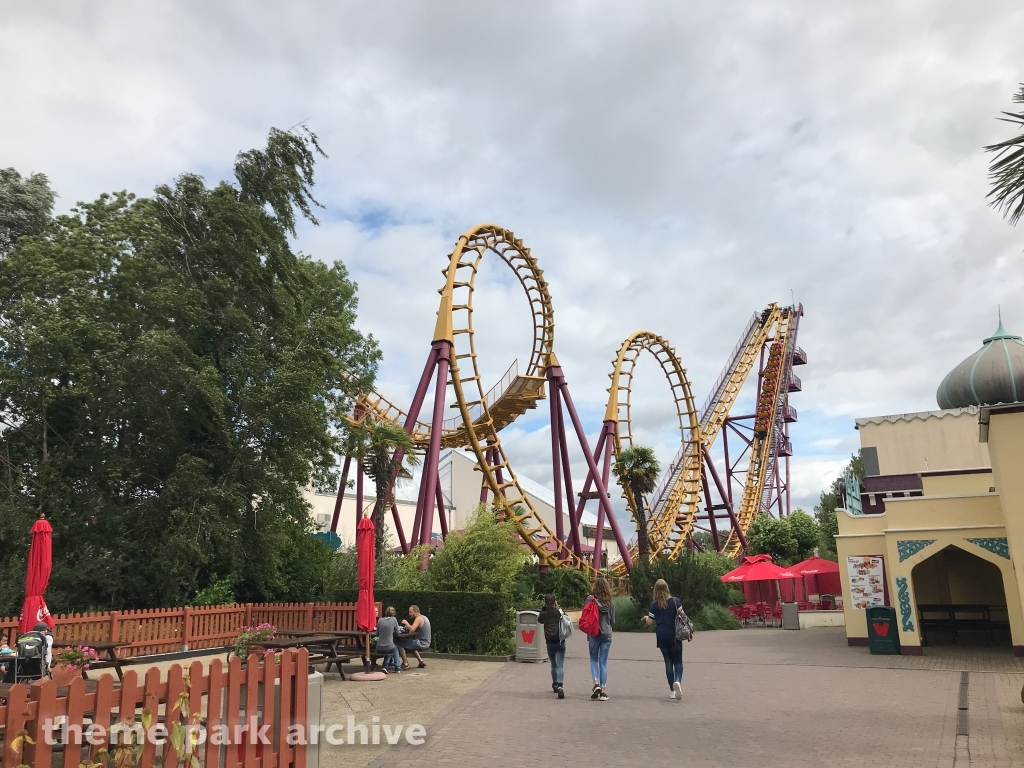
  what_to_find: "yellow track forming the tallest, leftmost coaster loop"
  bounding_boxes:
[353,224,593,572]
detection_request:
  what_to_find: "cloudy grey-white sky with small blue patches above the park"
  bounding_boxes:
[0,0,1024,524]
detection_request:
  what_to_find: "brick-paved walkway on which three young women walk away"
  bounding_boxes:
[364,629,1024,768]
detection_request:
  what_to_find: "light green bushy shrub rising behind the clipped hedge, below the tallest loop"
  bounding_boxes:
[426,504,530,593]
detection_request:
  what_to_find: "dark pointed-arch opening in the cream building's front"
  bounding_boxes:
[910,545,1011,647]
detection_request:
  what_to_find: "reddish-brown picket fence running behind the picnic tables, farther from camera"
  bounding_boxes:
[0,603,368,657]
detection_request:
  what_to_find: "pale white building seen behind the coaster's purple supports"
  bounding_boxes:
[305,450,620,565]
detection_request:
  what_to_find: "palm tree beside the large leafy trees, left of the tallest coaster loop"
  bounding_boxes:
[345,416,420,560]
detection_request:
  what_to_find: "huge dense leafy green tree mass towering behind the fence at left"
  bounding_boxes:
[0,130,379,610]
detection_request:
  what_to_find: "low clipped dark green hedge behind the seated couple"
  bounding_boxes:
[337,590,515,654]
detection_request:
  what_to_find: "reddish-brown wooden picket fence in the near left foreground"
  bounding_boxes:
[0,649,309,768]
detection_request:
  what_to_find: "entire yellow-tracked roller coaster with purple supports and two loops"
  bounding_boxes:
[331,224,807,575]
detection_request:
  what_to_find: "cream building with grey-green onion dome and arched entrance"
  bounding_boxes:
[837,323,1024,655]
